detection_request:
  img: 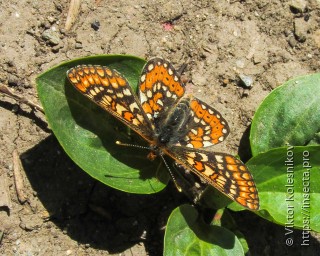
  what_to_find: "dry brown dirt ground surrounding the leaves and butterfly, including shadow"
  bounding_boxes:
[0,0,320,255]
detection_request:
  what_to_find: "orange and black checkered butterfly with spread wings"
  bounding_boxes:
[67,58,259,210]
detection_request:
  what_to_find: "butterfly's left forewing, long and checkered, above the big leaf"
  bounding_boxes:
[67,65,152,141]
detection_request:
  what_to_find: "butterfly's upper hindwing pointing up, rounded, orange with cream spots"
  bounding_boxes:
[139,58,185,123]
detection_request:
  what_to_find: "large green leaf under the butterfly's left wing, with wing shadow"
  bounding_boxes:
[36,55,168,194]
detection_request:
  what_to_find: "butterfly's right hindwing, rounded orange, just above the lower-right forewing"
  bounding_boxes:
[178,97,229,148]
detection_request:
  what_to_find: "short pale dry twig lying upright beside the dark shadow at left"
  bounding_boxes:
[12,149,27,204]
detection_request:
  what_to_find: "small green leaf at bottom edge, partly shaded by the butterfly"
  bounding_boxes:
[164,205,244,256]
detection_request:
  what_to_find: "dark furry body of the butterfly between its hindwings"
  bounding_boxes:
[155,98,190,147]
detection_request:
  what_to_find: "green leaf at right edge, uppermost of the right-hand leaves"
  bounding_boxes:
[250,73,320,156]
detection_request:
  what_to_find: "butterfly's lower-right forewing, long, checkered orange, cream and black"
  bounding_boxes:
[167,147,259,210]
